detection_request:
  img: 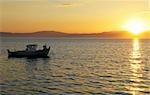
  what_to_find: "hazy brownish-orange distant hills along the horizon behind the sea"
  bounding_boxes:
[0,31,150,39]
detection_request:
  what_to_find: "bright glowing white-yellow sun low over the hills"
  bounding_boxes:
[123,19,148,35]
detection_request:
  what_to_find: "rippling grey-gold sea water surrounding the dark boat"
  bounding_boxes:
[0,38,150,95]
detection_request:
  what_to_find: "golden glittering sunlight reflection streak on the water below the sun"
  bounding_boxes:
[129,38,144,95]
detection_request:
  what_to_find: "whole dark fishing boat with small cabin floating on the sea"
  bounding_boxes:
[7,44,50,58]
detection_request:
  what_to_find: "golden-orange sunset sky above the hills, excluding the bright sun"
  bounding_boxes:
[0,0,150,33]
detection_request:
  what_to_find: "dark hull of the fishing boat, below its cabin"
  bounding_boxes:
[8,48,50,58]
